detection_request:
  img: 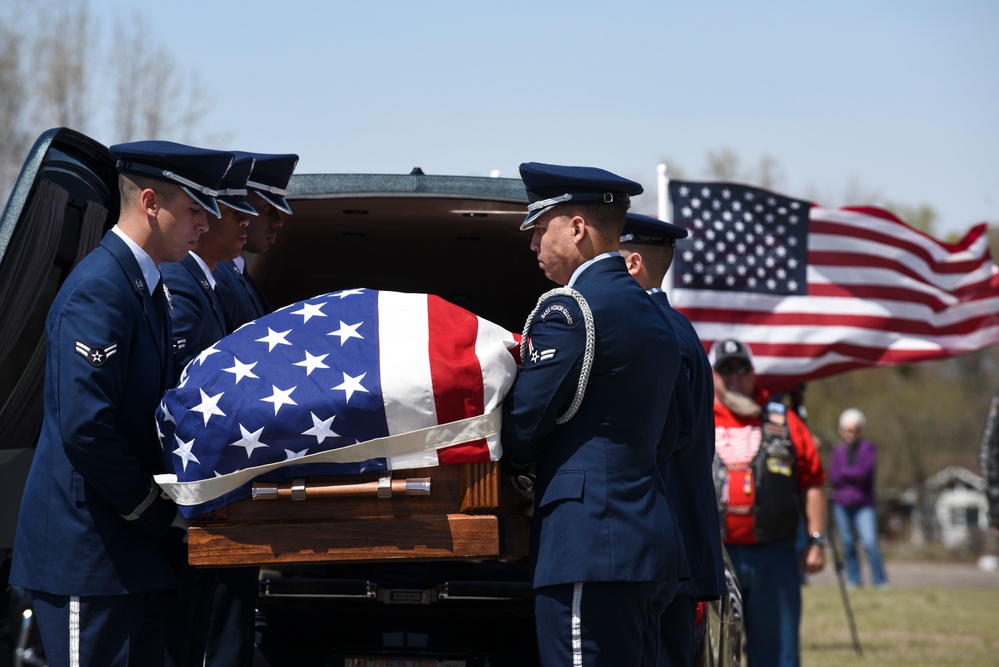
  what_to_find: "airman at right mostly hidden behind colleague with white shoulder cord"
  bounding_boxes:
[621,212,726,667]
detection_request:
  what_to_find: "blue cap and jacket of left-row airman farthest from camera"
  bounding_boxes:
[213,151,298,332]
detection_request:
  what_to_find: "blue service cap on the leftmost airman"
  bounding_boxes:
[108,141,233,217]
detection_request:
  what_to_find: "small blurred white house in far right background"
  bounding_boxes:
[900,466,989,548]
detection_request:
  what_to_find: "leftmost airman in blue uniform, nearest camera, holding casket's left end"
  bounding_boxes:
[10,141,233,667]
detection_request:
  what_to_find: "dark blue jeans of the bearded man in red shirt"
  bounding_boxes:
[725,540,801,667]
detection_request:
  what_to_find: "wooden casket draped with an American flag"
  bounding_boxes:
[156,289,532,565]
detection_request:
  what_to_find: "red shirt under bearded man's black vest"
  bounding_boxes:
[715,387,826,544]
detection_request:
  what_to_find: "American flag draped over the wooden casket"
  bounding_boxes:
[156,289,518,518]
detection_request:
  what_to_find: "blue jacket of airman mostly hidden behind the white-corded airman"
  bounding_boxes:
[652,291,725,600]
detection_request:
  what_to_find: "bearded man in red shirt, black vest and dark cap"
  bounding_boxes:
[708,339,826,667]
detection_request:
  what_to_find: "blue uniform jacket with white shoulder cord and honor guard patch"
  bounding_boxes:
[502,256,682,588]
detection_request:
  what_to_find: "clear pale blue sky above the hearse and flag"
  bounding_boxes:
[80,0,999,240]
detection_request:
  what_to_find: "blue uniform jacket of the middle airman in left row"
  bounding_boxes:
[160,253,227,372]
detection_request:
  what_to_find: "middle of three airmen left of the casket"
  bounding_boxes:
[162,153,259,667]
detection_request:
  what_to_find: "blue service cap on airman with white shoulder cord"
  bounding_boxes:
[520,162,644,231]
